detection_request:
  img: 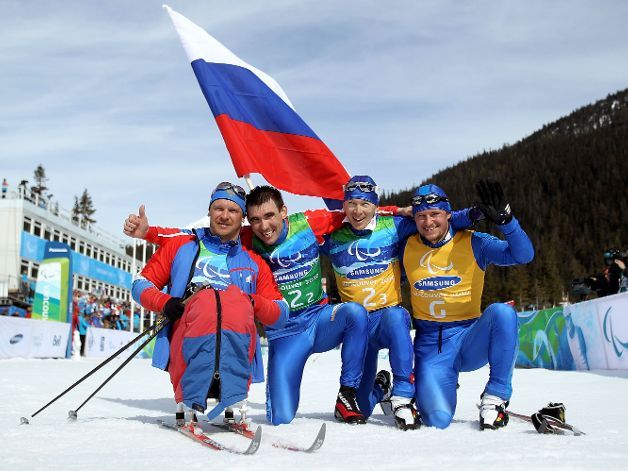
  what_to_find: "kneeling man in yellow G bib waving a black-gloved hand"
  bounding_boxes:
[402,181,534,430]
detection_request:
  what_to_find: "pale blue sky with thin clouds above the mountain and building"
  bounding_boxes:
[0,0,628,237]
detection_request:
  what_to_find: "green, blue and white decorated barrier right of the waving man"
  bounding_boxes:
[517,293,628,370]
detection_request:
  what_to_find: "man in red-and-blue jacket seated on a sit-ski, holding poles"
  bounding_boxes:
[125,182,289,425]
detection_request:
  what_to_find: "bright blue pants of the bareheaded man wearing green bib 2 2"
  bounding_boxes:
[266,303,368,425]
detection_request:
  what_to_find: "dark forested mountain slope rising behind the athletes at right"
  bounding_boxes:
[382,89,628,307]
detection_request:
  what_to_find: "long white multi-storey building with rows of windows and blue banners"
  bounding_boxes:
[0,187,146,314]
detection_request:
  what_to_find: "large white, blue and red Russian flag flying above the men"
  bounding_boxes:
[164,5,349,200]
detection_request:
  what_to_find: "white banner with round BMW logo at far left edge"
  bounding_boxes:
[0,316,70,358]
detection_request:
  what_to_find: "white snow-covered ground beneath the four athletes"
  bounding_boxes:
[0,350,628,471]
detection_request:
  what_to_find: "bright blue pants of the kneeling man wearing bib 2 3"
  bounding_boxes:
[357,306,414,417]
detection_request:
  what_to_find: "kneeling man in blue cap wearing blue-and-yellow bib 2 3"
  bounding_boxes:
[322,175,478,430]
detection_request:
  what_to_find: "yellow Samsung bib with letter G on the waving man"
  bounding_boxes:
[403,231,484,322]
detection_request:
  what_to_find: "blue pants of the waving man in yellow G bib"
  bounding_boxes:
[414,303,519,428]
